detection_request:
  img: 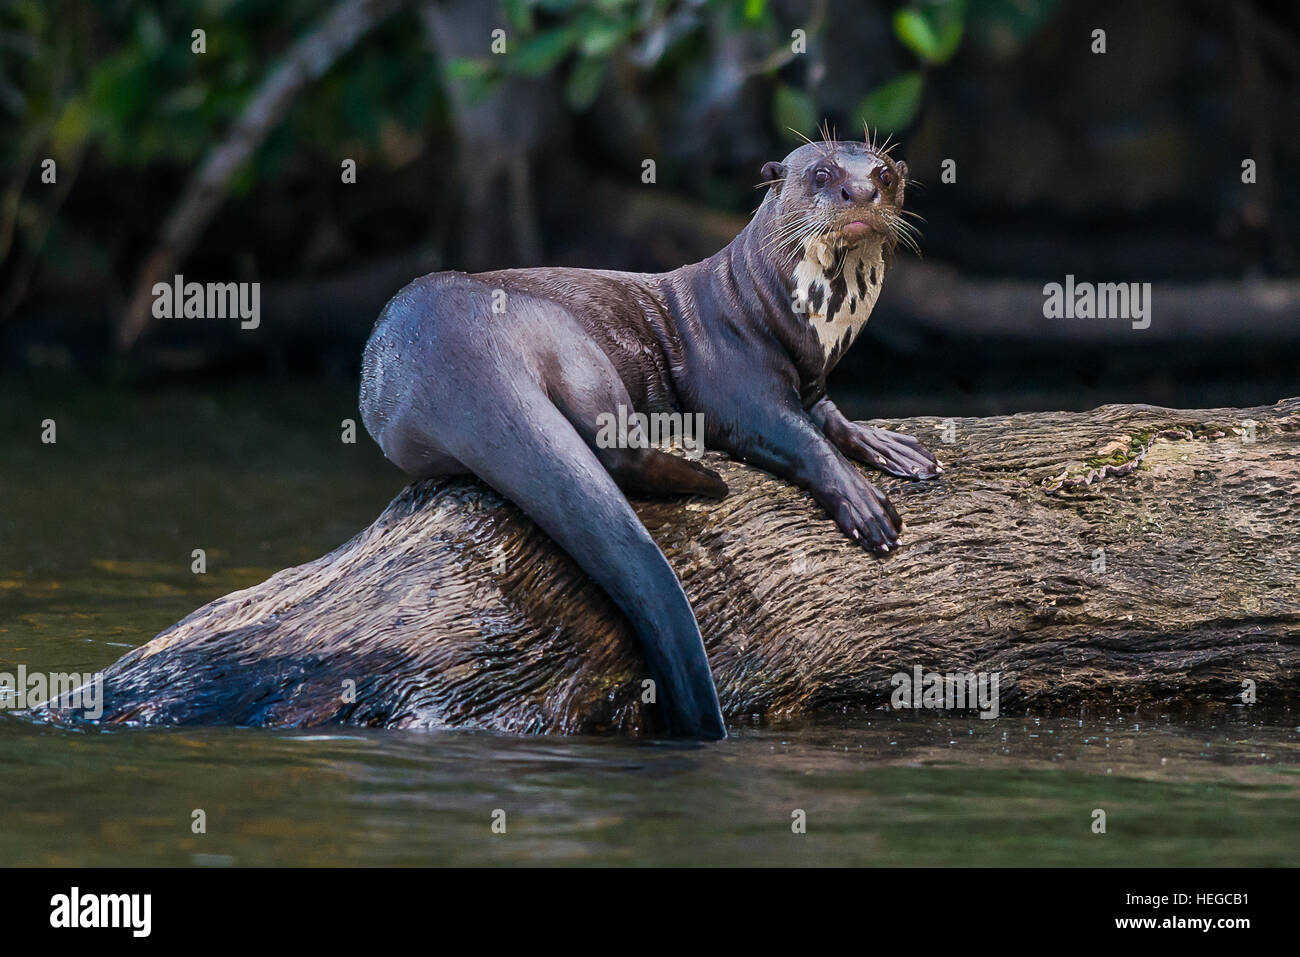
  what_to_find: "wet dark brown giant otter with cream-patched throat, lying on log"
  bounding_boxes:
[360,138,941,737]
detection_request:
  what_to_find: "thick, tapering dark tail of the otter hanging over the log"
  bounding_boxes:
[442,390,727,737]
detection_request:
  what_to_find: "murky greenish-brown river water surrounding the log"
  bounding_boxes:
[0,384,1300,866]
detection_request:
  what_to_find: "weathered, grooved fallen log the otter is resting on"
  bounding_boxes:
[47,398,1300,732]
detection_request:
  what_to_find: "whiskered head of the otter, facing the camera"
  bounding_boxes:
[763,133,915,261]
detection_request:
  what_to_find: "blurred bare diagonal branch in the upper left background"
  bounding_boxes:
[117,0,406,351]
